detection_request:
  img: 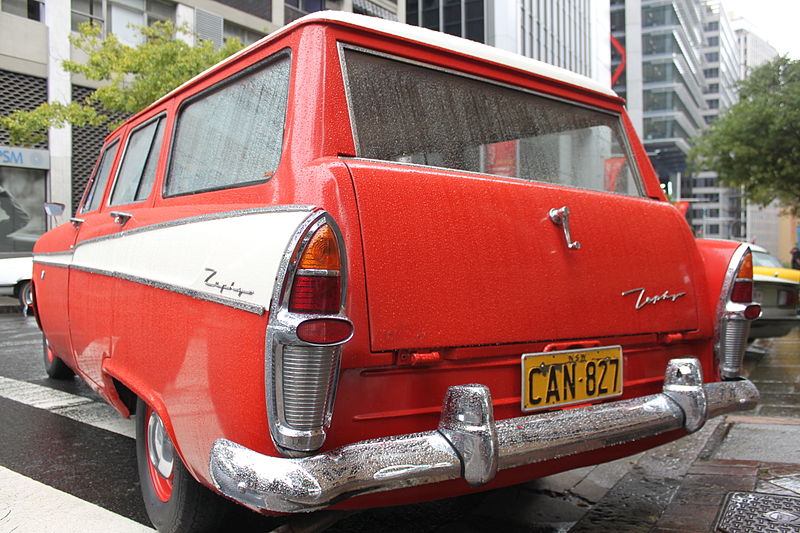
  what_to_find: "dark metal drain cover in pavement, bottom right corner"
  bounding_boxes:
[717,492,800,533]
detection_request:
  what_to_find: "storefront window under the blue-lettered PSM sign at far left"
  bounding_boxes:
[0,166,47,255]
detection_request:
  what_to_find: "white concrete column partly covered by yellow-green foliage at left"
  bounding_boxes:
[44,0,72,224]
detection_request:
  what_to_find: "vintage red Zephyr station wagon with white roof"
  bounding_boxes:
[34,12,760,531]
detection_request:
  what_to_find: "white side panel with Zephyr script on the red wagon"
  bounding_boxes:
[36,209,310,310]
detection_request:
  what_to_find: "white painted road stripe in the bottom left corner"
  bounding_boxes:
[0,466,155,533]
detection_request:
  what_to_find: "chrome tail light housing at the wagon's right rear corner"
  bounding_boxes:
[715,244,761,380]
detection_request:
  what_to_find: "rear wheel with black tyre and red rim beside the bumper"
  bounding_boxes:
[136,399,231,533]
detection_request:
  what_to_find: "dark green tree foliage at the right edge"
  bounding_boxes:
[690,57,800,213]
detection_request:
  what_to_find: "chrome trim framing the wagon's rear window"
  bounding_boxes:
[337,41,648,198]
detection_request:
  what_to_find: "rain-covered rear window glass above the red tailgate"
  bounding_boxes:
[343,48,642,196]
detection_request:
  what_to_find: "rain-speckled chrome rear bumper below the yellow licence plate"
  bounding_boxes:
[210,358,758,512]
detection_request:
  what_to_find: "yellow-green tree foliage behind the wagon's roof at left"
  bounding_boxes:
[0,21,242,145]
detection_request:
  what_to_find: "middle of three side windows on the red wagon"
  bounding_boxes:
[110,115,165,205]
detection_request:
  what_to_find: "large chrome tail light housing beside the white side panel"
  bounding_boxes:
[265,211,353,457]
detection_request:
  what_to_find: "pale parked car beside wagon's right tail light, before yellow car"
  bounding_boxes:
[750,272,800,340]
